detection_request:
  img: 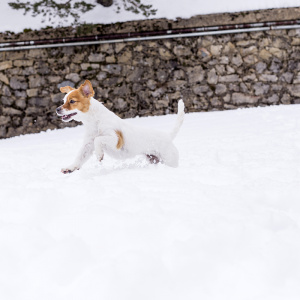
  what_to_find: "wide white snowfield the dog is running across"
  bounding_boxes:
[0,105,300,300]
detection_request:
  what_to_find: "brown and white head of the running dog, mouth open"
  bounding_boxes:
[56,80,95,122]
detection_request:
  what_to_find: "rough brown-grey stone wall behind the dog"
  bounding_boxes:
[0,9,300,138]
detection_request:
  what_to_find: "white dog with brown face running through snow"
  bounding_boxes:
[56,80,184,174]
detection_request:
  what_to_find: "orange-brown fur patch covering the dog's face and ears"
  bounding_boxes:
[61,80,95,113]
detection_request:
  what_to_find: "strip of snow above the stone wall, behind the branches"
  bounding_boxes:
[0,0,299,32]
